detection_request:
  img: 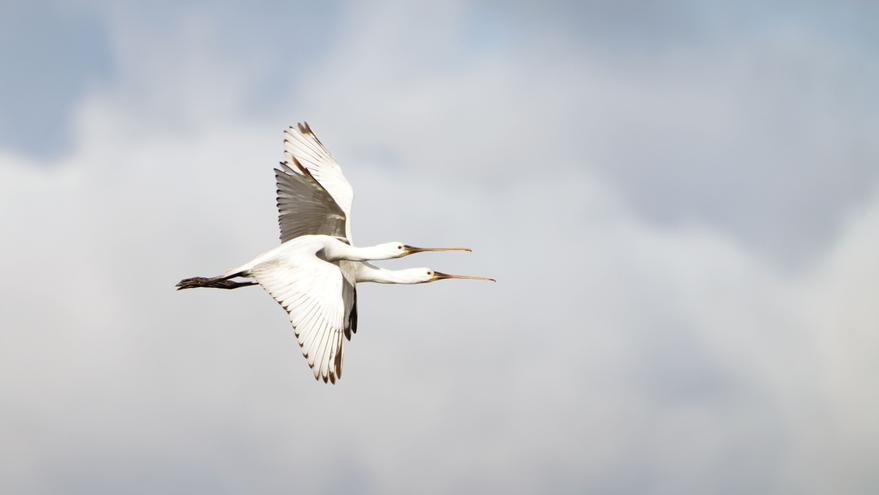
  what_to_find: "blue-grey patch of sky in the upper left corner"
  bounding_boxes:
[0,2,113,158]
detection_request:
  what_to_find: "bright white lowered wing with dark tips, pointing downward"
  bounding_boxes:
[250,256,356,383]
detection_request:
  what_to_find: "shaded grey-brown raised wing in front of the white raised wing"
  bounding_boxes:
[275,158,346,242]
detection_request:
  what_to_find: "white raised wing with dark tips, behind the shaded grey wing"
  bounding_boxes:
[284,122,354,240]
